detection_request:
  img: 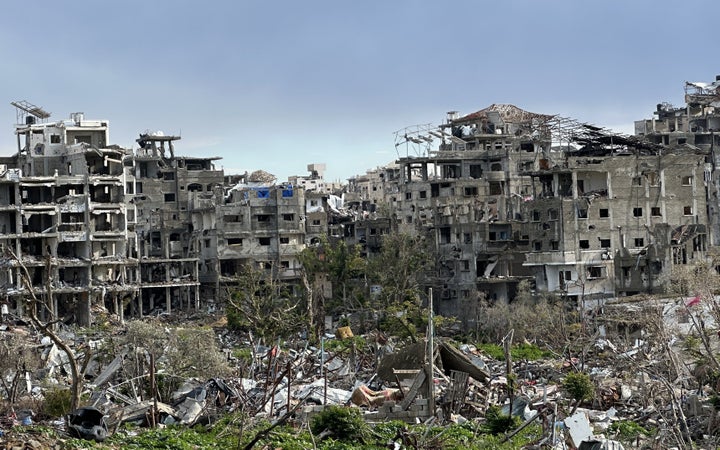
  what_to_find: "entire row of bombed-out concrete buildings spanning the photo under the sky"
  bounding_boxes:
[0,76,720,327]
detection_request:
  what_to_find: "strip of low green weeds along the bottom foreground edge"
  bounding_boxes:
[6,412,541,450]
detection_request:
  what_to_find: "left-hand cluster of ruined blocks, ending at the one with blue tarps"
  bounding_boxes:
[0,101,310,324]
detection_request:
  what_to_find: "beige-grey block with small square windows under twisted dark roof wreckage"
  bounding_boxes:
[525,142,708,300]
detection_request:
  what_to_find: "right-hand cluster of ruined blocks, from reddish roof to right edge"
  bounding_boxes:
[376,74,720,320]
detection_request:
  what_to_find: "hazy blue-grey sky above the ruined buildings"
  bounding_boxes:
[0,0,720,181]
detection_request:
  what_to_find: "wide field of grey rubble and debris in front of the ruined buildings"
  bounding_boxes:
[0,306,718,448]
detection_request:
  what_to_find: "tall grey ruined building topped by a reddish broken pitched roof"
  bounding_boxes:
[391,105,552,314]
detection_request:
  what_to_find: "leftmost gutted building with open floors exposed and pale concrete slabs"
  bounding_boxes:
[0,101,139,324]
